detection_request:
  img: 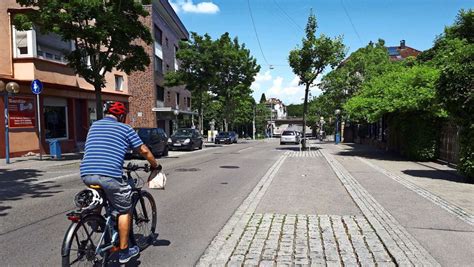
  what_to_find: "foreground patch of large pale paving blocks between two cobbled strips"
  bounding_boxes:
[227,213,395,266]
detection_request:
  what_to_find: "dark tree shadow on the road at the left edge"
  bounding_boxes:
[0,169,61,217]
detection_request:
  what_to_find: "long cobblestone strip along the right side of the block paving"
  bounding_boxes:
[322,151,439,266]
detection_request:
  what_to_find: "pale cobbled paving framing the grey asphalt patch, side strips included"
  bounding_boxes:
[196,150,439,266]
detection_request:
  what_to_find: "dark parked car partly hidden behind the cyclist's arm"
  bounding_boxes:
[127,128,168,158]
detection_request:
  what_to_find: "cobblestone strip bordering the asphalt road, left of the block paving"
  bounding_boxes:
[196,152,288,266]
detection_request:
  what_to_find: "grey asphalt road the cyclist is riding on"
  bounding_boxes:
[0,142,282,266]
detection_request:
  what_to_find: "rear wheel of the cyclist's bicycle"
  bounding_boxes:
[62,215,107,266]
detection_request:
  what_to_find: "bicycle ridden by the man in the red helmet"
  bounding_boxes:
[61,163,157,266]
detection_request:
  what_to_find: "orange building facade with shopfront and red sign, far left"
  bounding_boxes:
[0,0,129,157]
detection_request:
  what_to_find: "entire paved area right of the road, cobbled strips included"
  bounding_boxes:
[197,144,474,266]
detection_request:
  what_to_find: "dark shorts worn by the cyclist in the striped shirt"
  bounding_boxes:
[82,175,132,214]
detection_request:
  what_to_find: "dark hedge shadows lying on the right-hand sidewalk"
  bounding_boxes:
[337,144,469,183]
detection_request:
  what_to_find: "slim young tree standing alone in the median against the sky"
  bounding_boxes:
[288,12,344,149]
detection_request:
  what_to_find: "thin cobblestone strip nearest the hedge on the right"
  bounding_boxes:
[359,158,474,225]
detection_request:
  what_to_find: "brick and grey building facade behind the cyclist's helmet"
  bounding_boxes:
[128,0,196,135]
